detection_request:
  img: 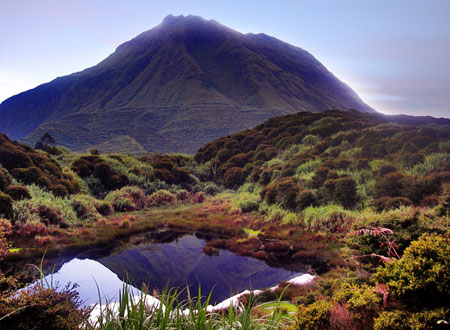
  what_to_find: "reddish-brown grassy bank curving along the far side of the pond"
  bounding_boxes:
[2,202,334,274]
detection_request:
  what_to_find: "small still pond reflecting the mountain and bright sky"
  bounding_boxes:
[42,235,304,305]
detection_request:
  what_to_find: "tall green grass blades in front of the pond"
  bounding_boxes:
[82,285,295,330]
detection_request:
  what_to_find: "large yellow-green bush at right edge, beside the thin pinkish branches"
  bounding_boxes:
[374,234,450,307]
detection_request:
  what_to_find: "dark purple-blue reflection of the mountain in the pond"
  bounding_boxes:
[98,236,295,303]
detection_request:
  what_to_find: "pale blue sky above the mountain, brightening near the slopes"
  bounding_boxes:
[0,0,450,118]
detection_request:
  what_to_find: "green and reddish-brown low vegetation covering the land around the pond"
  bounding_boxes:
[0,111,450,329]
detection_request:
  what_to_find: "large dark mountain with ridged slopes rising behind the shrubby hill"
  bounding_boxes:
[0,16,374,153]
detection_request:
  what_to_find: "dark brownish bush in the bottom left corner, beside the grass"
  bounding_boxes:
[0,285,89,330]
